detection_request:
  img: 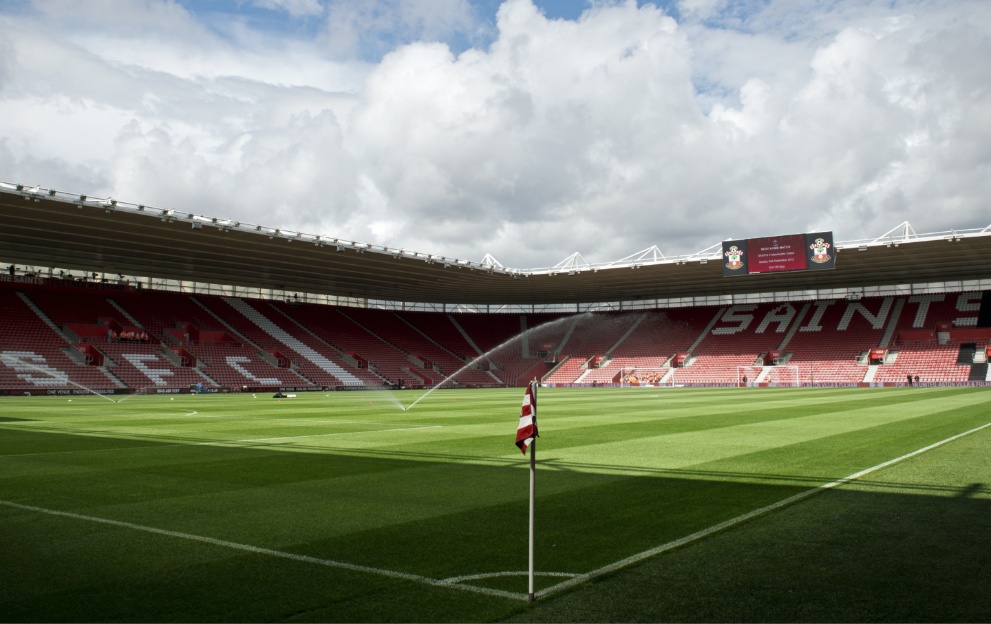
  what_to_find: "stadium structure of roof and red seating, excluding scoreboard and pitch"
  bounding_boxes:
[0,183,991,394]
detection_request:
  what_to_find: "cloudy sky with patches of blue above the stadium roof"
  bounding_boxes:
[0,0,991,268]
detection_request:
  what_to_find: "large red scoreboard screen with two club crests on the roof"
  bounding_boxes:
[723,232,836,277]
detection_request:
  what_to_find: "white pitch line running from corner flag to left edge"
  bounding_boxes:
[0,500,527,601]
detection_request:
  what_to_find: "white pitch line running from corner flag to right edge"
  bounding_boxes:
[535,423,991,598]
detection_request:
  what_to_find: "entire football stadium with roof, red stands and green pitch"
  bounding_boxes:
[0,182,991,622]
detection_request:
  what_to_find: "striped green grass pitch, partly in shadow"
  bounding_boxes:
[0,388,991,621]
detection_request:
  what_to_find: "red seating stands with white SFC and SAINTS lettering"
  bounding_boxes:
[0,282,991,391]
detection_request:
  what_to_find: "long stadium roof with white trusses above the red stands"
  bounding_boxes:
[0,183,991,305]
